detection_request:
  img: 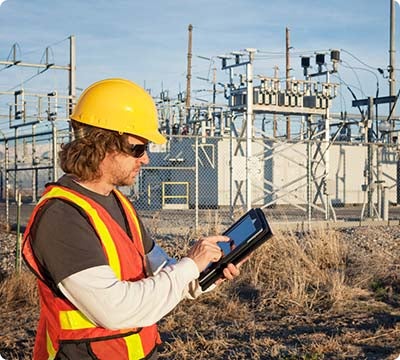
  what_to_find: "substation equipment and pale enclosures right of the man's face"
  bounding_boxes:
[136,49,398,220]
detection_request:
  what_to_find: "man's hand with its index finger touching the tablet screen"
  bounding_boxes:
[187,235,230,276]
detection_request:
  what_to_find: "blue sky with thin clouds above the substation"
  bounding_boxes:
[0,0,400,121]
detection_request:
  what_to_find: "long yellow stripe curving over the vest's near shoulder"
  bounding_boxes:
[39,187,122,280]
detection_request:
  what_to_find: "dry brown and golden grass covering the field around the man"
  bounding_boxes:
[0,224,400,360]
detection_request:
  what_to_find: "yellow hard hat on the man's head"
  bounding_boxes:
[71,79,167,144]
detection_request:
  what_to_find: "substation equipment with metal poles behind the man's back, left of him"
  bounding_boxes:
[0,36,76,228]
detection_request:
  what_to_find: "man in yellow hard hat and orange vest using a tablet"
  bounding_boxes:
[23,79,239,360]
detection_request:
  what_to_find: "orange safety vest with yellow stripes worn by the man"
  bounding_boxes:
[23,185,161,360]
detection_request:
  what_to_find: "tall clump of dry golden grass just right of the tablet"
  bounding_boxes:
[241,226,351,312]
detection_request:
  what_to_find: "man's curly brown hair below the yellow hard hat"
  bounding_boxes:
[58,120,130,181]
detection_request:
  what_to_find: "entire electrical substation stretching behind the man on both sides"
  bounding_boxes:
[0,26,400,228]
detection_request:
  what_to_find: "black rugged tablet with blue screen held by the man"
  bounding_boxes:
[199,208,273,290]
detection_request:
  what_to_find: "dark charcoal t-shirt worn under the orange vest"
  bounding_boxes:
[32,175,153,285]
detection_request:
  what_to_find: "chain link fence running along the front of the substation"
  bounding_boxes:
[0,130,400,232]
